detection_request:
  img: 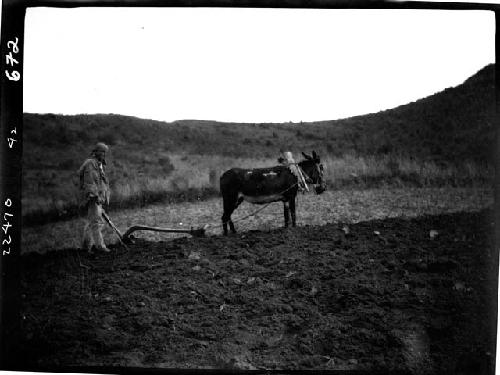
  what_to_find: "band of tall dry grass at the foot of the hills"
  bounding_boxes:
[22,154,493,223]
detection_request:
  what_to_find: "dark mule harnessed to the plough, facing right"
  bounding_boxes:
[220,151,326,235]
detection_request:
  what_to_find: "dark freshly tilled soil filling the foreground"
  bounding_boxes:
[21,211,497,374]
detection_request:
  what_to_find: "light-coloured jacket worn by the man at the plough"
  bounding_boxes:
[78,157,110,206]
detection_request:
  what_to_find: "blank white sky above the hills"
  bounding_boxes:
[24,8,495,122]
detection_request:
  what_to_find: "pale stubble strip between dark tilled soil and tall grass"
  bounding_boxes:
[22,188,493,252]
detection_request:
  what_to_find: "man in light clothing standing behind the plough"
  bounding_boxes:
[78,142,110,253]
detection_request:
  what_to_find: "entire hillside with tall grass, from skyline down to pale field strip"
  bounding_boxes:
[23,65,495,223]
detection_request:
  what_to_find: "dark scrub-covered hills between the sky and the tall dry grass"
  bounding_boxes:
[24,65,495,164]
